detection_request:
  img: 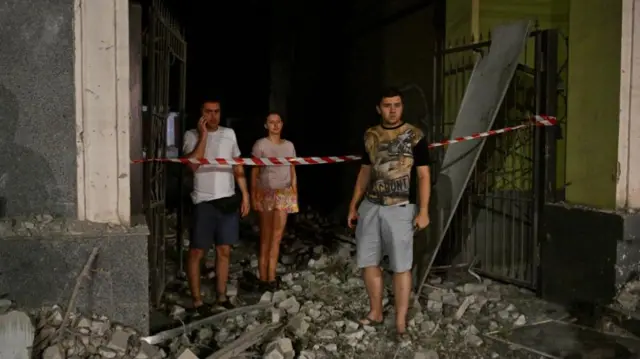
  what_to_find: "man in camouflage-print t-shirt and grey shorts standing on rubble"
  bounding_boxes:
[347,88,431,339]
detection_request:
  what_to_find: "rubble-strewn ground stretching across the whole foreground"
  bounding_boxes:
[0,211,638,359]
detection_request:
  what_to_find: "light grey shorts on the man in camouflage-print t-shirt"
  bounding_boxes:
[356,199,416,273]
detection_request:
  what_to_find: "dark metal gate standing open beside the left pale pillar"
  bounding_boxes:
[143,0,187,306]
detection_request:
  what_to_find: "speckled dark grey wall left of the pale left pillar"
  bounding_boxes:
[0,0,77,217]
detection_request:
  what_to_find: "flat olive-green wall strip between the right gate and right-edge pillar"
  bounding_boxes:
[567,0,622,209]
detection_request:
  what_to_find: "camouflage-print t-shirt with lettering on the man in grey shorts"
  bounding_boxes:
[362,123,431,206]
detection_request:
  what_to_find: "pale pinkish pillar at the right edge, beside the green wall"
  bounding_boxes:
[616,0,640,208]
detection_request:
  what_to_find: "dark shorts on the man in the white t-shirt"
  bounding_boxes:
[189,202,240,250]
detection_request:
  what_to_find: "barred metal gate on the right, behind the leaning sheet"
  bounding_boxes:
[431,30,564,288]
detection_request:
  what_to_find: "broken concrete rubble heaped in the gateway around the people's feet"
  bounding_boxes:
[159,213,568,359]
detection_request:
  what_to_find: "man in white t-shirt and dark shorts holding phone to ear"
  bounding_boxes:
[183,100,249,315]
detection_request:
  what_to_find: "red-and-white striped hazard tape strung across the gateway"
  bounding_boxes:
[131,115,558,166]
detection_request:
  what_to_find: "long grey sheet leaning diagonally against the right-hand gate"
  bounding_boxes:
[419,21,531,296]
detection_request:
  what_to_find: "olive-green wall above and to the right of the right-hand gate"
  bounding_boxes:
[447,0,621,208]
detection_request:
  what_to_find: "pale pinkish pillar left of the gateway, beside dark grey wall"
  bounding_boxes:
[74,0,131,224]
